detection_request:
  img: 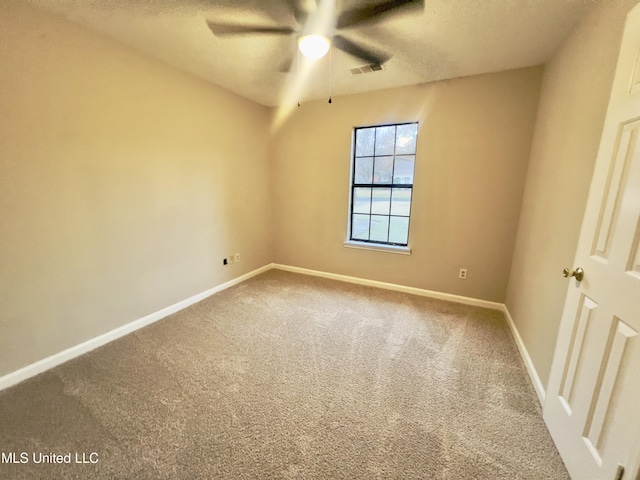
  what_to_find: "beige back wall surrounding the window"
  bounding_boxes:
[272,68,542,302]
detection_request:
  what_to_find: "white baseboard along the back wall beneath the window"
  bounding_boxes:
[272,263,504,311]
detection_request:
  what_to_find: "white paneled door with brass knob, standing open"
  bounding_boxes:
[544,5,640,480]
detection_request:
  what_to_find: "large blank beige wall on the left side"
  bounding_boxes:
[0,2,272,376]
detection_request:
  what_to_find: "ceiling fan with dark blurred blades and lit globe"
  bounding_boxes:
[207,0,424,72]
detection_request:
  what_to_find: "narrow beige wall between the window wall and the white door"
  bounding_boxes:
[506,0,637,385]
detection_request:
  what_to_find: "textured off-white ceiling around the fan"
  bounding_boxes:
[31,0,593,106]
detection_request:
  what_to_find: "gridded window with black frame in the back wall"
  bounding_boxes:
[349,123,418,246]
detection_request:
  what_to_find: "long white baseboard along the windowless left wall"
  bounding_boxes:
[0,264,272,390]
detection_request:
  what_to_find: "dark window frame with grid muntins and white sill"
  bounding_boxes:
[344,120,420,255]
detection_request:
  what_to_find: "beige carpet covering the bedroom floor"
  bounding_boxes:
[0,270,569,480]
